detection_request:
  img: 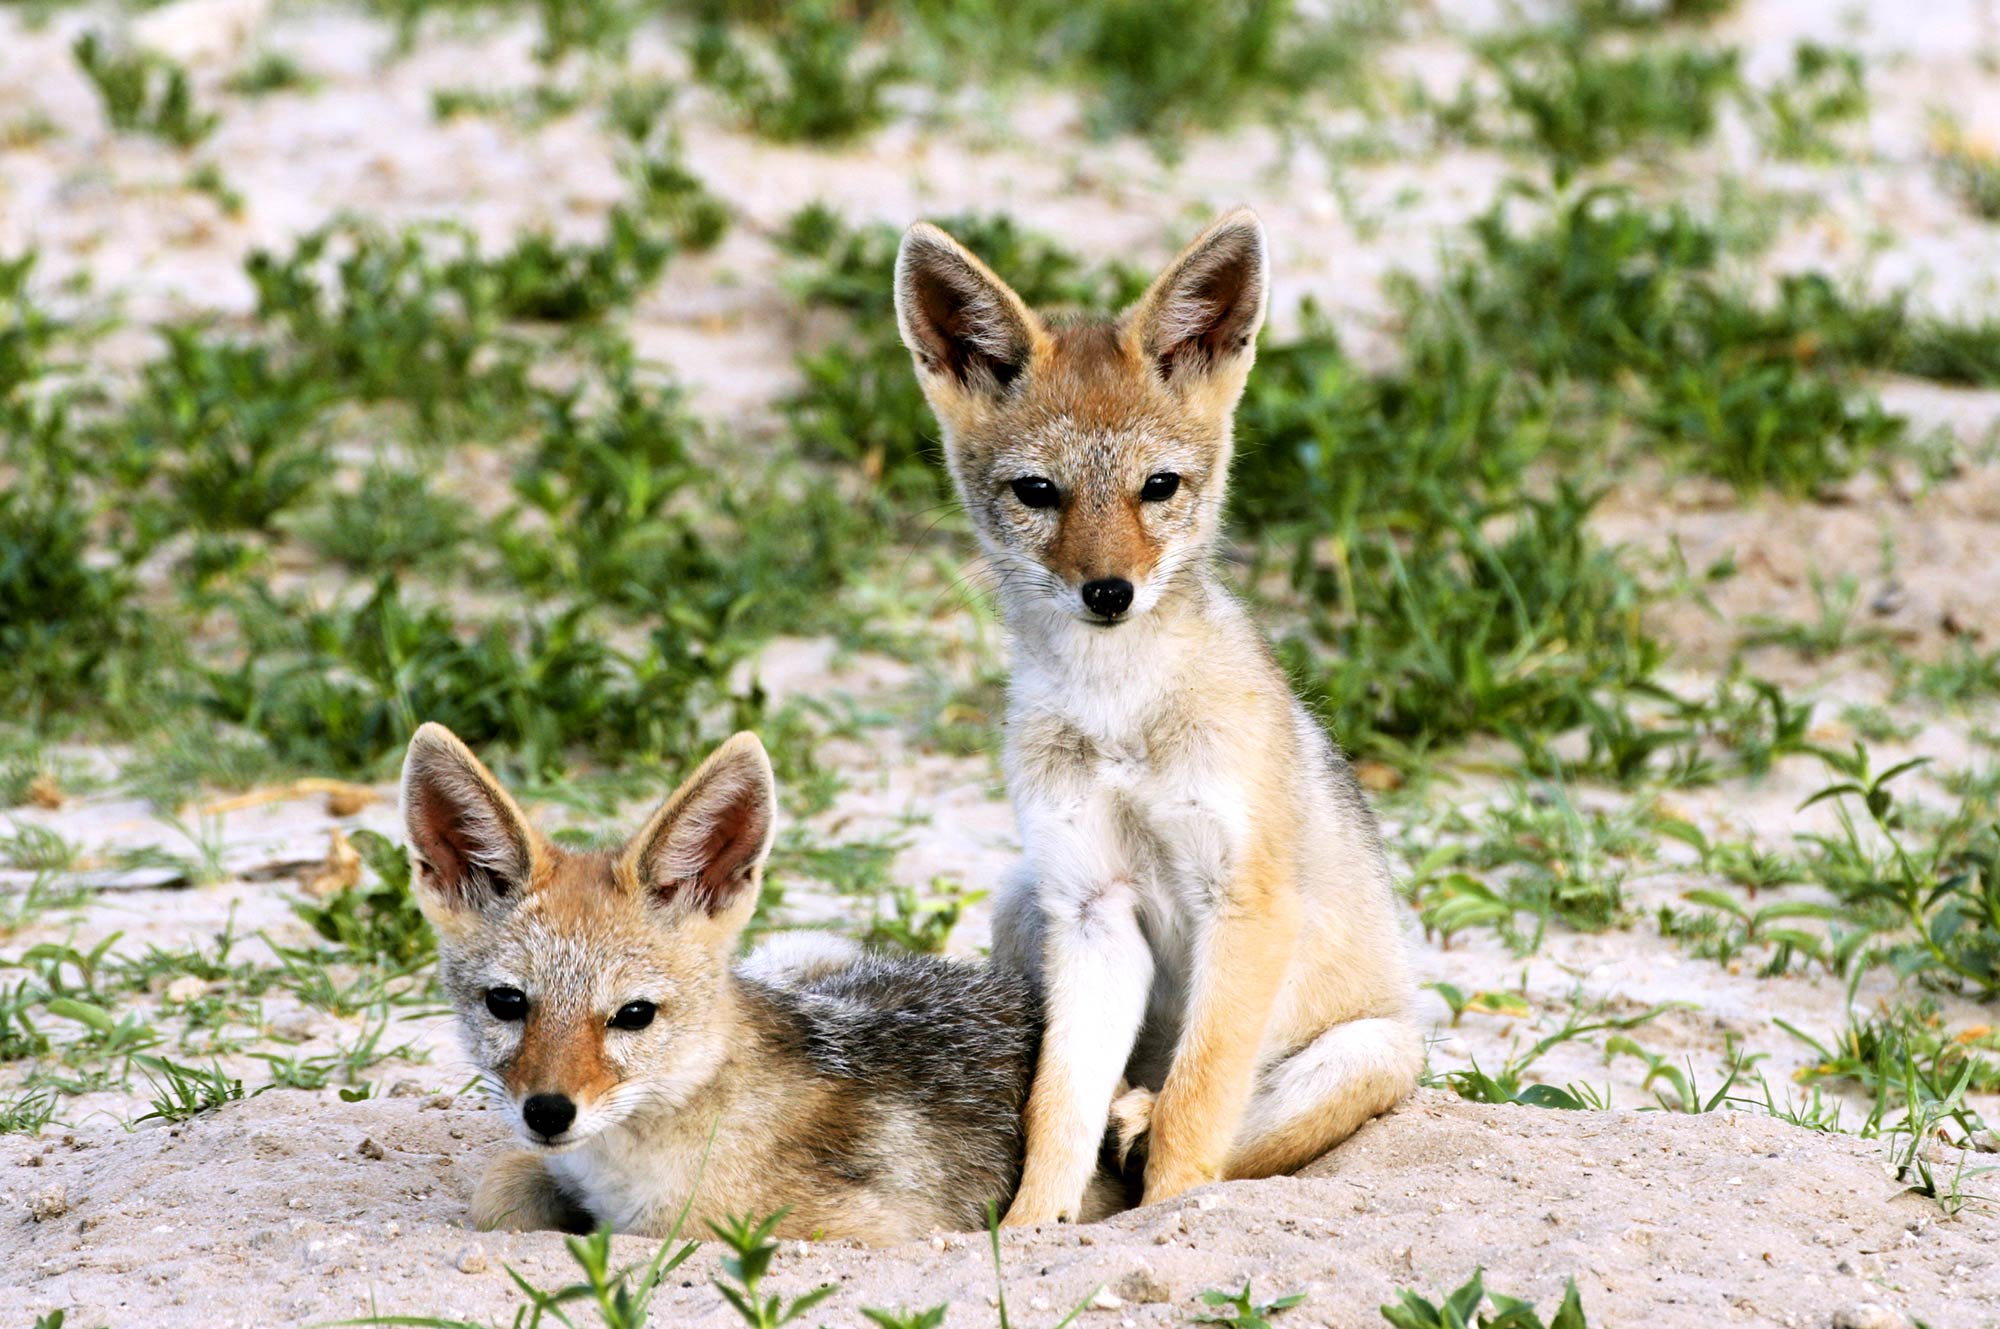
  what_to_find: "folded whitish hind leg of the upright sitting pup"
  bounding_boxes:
[1224,1019,1424,1177]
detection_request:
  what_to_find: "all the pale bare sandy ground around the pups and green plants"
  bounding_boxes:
[0,0,2000,1329]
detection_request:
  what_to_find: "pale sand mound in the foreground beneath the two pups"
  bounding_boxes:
[0,1091,2000,1329]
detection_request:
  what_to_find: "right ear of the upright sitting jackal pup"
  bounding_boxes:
[1126,208,1270,386]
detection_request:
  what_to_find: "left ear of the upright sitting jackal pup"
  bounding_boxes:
[896,222,1046,396]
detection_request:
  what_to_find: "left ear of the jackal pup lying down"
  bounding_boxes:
[402,723,534,911]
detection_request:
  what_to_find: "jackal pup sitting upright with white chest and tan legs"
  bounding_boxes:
[896,210,1424,1223]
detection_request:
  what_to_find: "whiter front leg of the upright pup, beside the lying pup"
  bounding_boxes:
[1006,881,1152,1227]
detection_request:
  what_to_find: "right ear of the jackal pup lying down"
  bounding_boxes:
[624,733,778,935]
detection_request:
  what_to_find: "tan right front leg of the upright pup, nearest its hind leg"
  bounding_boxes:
[1144,857,1300,1205]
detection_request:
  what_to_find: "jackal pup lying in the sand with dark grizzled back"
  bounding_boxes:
[402,725,1110,1243]
